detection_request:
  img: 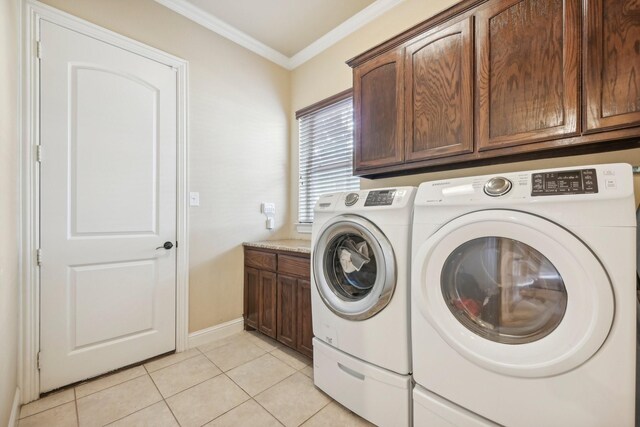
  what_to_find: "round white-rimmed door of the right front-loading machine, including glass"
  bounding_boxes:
[411,210,614,377]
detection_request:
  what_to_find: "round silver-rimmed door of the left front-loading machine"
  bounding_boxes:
[313,215,396,320]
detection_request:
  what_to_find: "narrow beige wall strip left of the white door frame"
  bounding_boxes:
[0,0,19,426]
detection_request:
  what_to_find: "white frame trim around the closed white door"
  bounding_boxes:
[18,0,189,403]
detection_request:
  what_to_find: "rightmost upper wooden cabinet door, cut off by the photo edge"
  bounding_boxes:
[584,0,640,132]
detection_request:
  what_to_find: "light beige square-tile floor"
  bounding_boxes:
[19,332,371,427]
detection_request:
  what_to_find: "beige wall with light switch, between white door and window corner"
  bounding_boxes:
[45,0,290,331]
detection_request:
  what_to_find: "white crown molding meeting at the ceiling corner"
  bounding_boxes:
[155,0,405,70]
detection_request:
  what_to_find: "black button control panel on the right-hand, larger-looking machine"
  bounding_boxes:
[531,169,598,196]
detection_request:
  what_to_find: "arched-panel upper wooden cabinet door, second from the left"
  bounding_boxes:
[404,18,473,161]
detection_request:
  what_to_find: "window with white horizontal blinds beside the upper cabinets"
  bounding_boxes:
[296,90,360,224]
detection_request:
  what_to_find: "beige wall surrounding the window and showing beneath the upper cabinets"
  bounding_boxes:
[291,0,640,221]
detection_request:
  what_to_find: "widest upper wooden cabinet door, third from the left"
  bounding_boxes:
[476,0,580,152]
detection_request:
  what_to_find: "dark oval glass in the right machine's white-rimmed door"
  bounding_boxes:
[441,237,567,344]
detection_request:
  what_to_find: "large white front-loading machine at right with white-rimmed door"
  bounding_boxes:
[411,164,636,427]
